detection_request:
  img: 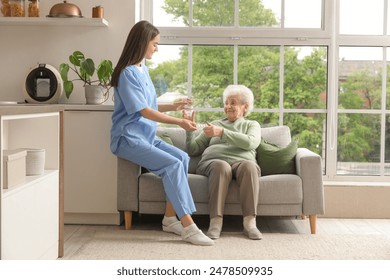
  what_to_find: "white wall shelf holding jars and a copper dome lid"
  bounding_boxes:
[0,17,108,27]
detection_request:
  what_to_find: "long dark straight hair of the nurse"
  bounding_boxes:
[111,20,160,87]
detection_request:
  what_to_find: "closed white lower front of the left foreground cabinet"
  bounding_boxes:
[1,170,59,260]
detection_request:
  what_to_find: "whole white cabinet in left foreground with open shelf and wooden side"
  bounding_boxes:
[0,106,63,259]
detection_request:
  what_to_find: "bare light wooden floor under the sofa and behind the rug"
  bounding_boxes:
[64,215,390,258]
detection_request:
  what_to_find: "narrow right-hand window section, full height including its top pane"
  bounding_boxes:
[336,0,390,177]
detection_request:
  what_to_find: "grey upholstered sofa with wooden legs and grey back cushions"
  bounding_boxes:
[118,126,324,234]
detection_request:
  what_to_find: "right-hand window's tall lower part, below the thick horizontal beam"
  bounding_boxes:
[337,47,383,175]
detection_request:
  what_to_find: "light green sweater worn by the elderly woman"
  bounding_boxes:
[186,118,261,164]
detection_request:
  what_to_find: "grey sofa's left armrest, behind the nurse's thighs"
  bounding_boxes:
[117,157,141,212]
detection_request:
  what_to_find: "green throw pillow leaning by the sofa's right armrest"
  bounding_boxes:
[257,139,298,176]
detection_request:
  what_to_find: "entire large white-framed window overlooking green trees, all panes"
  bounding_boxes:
[145,0,390,180]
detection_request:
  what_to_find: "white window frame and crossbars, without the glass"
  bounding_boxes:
[139,0,390,182]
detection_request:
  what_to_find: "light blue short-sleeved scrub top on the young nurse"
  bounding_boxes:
[111,64,158,154]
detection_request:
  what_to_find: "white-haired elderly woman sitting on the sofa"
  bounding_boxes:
[184,85,262,240]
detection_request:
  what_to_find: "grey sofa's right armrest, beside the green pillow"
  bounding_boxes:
[295,148,325,215]
